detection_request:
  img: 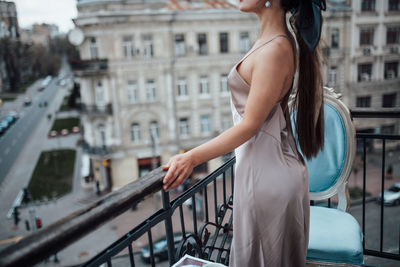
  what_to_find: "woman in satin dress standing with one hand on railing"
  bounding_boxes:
[163,0,325,267]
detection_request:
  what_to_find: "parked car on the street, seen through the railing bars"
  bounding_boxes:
[140,233,188,263]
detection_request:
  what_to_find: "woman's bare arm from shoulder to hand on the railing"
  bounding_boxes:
[163,38,293,193]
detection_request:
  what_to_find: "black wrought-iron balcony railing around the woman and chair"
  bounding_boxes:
[0,108,400,266]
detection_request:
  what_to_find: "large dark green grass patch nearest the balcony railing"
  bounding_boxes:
[28,149,76,200]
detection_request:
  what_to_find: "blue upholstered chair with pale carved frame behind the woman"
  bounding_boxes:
[292,87,364,266]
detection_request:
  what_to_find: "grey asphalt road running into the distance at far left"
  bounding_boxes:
[0,78,59,184]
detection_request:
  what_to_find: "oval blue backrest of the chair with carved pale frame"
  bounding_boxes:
[293,87,356,211]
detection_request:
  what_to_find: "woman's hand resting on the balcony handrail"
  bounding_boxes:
[162,151,196,191]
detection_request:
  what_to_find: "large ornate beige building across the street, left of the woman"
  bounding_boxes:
[72,0,258,189]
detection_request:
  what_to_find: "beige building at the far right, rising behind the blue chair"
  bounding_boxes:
[348,0,400,136]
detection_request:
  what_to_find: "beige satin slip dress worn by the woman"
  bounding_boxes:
[228,35,310,267]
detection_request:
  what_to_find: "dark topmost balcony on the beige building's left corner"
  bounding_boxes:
[69,58,108,76]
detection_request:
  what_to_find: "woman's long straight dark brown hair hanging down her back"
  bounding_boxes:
[281,0,324,159]
